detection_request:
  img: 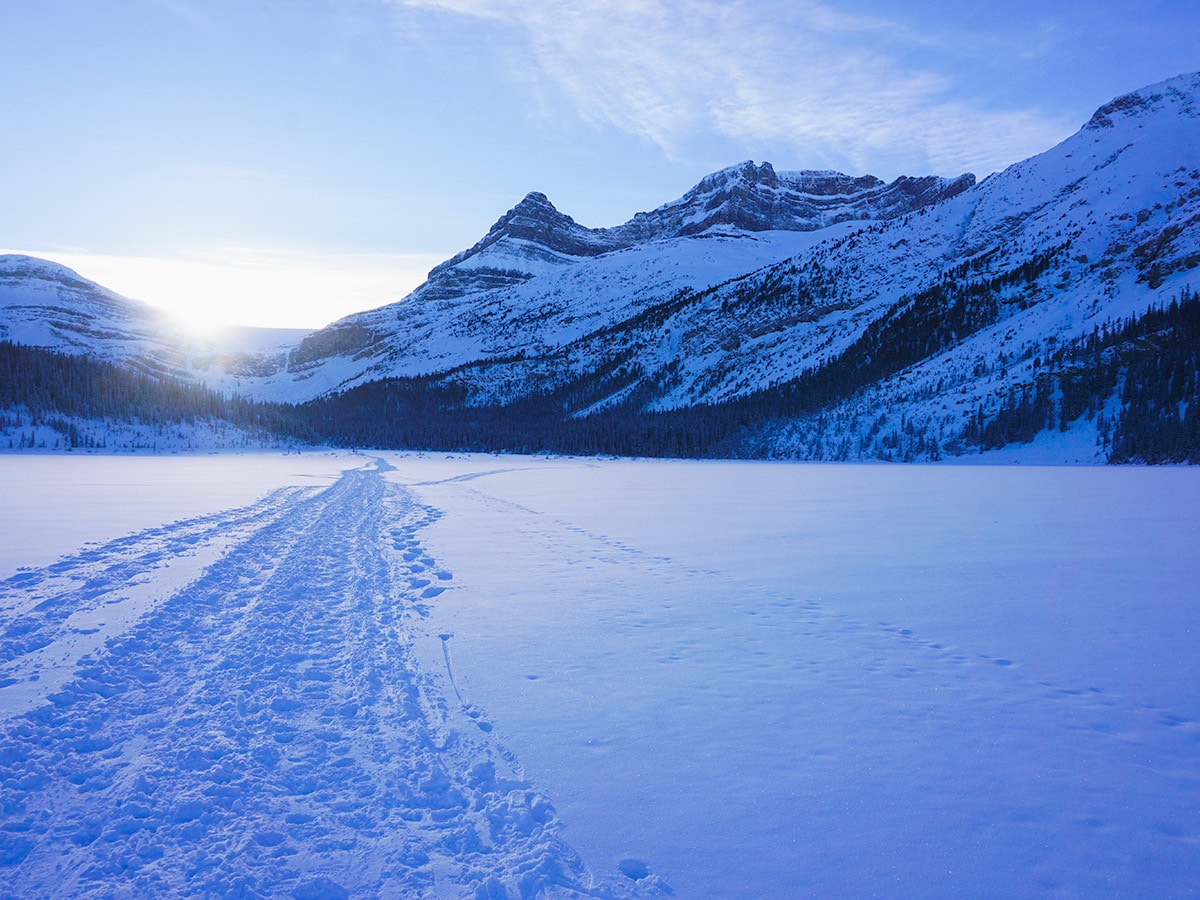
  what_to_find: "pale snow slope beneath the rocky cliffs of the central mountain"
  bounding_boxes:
[231,224,848,402]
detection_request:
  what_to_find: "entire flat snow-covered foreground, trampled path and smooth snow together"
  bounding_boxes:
[0,454,1200,898]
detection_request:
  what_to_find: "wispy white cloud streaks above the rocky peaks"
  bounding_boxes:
[394,0,1078,174]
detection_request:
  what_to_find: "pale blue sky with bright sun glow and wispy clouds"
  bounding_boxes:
[0,0,1200,328]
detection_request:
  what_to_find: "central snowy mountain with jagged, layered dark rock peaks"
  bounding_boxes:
[236,162,974,400]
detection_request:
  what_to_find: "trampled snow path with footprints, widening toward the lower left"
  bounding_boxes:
[0,461,660,898]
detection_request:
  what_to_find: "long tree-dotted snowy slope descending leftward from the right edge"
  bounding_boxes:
[360,74,1200,456]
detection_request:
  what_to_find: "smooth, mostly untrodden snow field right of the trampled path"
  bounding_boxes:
[400,460,1200,898]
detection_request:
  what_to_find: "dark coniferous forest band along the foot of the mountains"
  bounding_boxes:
[0,286,1200,463]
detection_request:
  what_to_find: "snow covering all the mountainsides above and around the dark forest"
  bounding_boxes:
[0,74,1200,463]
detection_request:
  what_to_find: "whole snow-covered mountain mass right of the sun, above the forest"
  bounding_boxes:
[0,73,1200,458]
